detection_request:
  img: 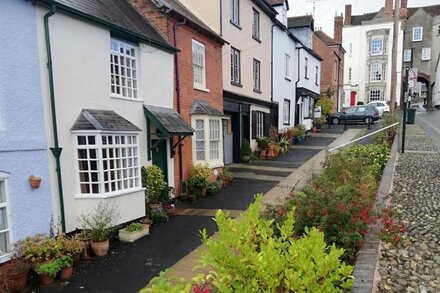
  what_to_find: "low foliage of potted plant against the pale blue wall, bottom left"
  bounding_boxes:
[14,234,61,263]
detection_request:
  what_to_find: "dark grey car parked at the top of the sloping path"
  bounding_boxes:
[327,105,379,125]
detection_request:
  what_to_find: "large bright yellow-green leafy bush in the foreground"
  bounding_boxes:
[144,195,353,292]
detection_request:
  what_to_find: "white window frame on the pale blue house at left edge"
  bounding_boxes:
[0,172,14,263]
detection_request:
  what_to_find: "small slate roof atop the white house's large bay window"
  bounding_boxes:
[70,109,141,131]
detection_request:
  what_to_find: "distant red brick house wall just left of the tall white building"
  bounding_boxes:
[313,34,344,111]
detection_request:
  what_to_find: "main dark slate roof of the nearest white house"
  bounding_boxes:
[36,0,173,49]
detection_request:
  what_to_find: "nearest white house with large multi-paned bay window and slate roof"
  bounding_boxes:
[32,0,187,232]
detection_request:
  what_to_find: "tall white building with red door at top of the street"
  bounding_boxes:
[342,0,403,107]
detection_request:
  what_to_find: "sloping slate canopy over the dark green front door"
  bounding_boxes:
[144,105,194,135]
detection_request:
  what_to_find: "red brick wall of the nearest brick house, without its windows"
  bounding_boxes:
[131,0,223,193]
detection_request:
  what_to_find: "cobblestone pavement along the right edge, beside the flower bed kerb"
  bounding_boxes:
[379,125,440,293]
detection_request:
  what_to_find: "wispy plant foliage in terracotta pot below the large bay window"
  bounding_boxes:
[78,201,120,242]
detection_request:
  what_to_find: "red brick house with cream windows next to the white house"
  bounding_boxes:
[130,0,224,193]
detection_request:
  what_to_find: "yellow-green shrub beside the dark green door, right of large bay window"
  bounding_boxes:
[141,165,167,203]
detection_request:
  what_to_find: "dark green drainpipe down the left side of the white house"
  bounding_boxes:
[44,5,66,233]
